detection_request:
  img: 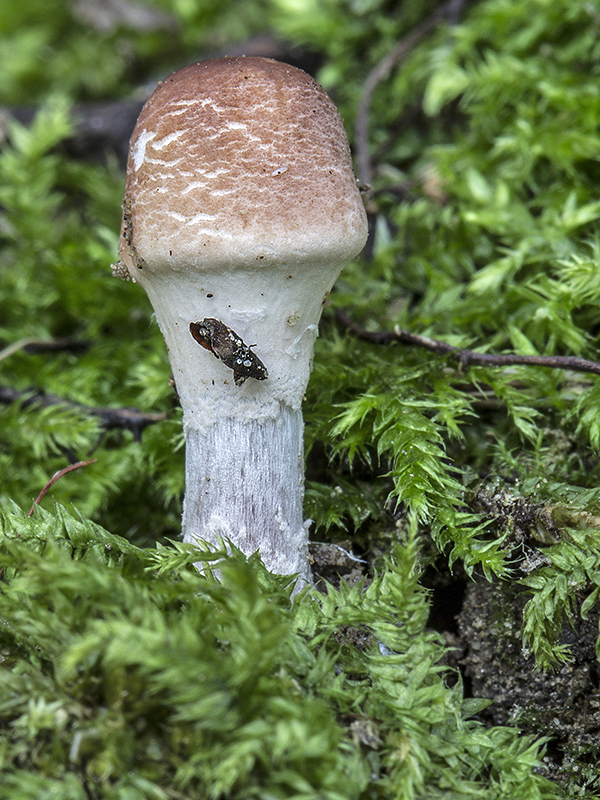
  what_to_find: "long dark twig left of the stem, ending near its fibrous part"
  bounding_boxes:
[0,385,167,442]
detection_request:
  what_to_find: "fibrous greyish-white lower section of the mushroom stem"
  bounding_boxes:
[183,404,310,582]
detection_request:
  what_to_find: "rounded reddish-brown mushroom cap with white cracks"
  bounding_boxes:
[120,57,367,274]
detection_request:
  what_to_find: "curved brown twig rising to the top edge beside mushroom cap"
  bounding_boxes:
[354,0,463,185]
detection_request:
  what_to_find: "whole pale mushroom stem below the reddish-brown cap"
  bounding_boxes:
[138,262,342,580]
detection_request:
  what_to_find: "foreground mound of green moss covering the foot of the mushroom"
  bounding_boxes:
[0,507,558,800]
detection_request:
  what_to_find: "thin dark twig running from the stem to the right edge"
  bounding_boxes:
[335,310,600,375]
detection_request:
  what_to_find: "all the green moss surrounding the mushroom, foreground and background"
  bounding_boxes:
[0,0,600,798]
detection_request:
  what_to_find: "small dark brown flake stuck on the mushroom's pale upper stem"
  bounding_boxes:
[190,317,269,386]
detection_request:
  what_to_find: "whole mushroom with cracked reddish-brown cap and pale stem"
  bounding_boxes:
[116,58,367,580]
